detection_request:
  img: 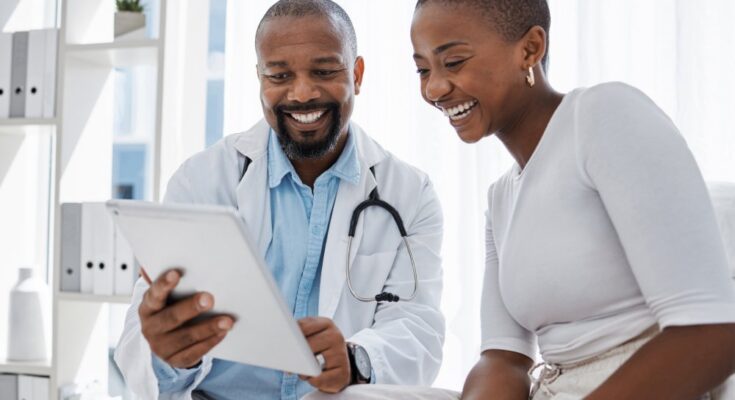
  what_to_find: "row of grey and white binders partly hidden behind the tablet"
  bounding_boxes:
[61,203,140,296]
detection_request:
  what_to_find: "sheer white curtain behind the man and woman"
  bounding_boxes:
[224,0,735,389]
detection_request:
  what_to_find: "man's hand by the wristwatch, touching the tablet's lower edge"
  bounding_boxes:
[299,317,352,393]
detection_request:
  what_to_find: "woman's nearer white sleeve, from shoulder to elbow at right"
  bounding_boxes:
[575,84,735,328]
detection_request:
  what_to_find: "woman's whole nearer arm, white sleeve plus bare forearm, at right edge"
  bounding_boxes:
[577,84,735,399]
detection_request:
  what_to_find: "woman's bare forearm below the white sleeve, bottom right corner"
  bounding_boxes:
[587,324,735,400]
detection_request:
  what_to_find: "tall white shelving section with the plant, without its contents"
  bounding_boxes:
[50,0,166,399]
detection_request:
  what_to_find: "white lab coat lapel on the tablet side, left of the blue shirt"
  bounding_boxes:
[235,121,273,257]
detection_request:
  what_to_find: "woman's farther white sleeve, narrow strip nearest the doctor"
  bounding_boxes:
[480,187,536,360]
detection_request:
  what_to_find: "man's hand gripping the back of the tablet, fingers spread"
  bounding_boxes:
[138,270,234,368]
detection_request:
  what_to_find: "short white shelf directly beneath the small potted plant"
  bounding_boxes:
[65,39,160,68]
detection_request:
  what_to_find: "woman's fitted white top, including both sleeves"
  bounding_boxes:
[482,83,735,363]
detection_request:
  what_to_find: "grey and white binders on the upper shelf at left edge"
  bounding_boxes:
[0,29,59,119]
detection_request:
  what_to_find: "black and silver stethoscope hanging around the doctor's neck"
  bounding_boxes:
[240,157,419,303]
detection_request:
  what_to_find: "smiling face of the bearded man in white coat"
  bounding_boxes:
[256,16,363,159]
